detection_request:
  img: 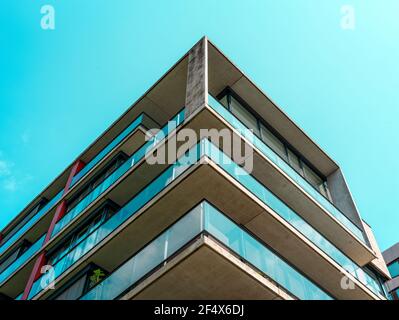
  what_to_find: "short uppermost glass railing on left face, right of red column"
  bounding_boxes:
[71,113,148,187]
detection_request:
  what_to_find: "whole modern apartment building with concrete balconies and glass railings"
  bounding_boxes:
[0,37,390,300]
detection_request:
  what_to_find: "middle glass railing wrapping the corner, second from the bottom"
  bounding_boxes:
[29,140,383,298]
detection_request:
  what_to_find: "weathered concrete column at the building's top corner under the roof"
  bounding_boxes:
[185,37,208,118]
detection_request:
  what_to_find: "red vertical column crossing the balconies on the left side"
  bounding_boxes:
[21,160,85,300]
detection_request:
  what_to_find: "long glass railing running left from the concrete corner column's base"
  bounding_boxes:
[52,109,184,237]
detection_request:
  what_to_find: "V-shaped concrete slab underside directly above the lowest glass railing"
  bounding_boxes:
[29,159,380,299]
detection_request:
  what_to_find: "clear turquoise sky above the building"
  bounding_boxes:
[0,0,399,249]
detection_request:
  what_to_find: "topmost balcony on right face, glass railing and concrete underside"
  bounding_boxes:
[200,95,375,265]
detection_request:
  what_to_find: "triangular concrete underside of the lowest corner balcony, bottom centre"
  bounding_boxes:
[120,236,295,300]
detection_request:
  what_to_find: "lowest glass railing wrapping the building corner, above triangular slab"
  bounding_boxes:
[81,201,332,300]
